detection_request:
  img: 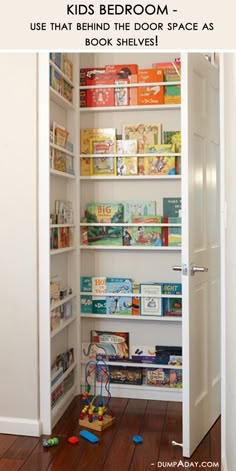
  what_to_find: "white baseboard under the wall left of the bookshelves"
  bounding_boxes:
[0,417,41,437]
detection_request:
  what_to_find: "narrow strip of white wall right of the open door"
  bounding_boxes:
[222,54,236,471]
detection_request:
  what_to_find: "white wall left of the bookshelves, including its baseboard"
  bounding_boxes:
[0,53,38,434]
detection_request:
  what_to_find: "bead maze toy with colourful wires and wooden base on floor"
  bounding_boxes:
[79,360,115,432]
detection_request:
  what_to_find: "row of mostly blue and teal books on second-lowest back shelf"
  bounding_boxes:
[80,276,182,317]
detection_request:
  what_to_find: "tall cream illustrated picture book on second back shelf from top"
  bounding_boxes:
[122,123,162,154]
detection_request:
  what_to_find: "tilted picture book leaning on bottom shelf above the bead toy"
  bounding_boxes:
[91,330,129,359]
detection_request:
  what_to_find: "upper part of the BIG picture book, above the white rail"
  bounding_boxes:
[86,202,124,223]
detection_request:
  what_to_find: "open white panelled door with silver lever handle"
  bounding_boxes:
[182,53,221,457]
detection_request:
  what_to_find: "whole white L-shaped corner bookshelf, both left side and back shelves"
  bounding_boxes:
[39,53,184,433]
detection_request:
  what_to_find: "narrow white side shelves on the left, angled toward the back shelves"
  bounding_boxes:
[39,54,79,434]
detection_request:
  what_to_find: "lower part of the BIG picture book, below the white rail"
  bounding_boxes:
[86,226,122,246]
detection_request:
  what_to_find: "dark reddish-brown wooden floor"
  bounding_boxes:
[0,397,221,471]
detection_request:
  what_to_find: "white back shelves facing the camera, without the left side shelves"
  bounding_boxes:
[79,53,182,401]
